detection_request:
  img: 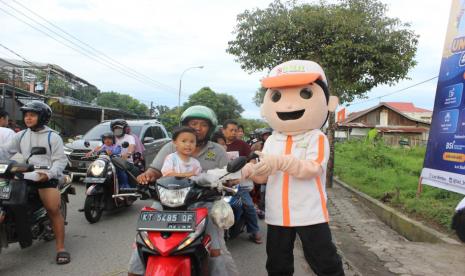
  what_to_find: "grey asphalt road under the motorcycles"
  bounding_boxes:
[0,183,316,276]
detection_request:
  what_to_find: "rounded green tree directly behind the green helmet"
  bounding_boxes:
[183,87,244,124]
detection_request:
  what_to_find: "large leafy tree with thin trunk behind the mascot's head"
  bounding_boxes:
[227,0,418,185]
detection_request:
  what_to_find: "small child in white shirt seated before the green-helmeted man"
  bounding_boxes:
[161,127,202,177]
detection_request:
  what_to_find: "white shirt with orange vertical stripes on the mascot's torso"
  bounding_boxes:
[263,129,329,226]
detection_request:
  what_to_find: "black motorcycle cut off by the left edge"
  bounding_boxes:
[0,147,76,251]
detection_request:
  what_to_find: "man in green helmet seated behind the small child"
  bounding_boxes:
[128,105,238,276]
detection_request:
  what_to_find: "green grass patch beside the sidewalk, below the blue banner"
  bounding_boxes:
[335,141,464,231]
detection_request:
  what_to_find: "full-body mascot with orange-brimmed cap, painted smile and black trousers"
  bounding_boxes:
[242,60,344,275]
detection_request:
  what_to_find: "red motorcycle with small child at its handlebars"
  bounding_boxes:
[121,157,247,276]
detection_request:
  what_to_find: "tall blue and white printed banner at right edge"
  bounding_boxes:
[420,0,465,194]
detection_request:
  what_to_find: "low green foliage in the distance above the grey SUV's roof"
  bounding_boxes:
[97,91,149,116]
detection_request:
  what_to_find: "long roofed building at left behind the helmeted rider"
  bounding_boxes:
[0,58,142,137]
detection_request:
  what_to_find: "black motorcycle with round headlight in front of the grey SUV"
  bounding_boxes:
[79,142,140,223]
